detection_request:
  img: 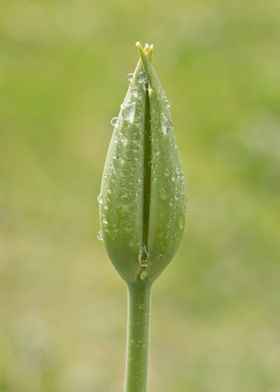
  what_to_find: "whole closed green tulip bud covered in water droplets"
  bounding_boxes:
[98,43,185,283]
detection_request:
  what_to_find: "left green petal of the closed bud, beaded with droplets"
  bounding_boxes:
[99,61,146,281]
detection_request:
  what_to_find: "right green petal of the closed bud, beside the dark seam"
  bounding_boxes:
[140,48,185,279]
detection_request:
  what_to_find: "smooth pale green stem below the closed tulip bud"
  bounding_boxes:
[124,280,151,392]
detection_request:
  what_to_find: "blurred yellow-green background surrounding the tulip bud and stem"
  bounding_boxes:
[0,0,280,392]
